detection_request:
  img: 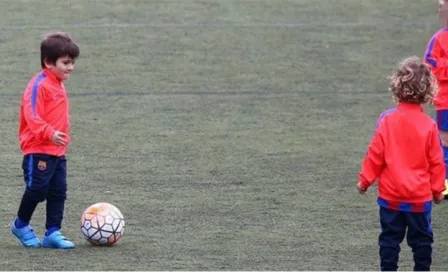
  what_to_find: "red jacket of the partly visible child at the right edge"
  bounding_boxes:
[424,28,448,110]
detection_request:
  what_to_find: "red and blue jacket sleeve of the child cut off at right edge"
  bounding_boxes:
[425,36,448,80]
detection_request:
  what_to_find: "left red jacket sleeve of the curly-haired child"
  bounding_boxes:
[359,122,384,189]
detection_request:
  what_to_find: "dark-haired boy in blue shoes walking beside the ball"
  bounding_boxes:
[11,33,79,249]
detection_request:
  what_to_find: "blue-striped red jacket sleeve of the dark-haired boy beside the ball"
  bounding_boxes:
[22,85,55,140]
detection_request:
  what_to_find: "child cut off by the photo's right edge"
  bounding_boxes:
[425,0,448,198]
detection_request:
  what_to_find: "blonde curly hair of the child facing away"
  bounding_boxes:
[389,57,438,104]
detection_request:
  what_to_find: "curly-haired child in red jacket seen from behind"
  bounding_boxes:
[358,57,445,271]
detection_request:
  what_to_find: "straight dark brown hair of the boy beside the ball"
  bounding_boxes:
[40,32,79,68]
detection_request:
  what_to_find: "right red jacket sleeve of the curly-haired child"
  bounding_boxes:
[428,124,446,196]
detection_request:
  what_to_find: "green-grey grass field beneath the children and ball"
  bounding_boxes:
[0,0,448,270]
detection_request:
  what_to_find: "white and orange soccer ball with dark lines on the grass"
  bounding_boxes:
[81,202,124,246]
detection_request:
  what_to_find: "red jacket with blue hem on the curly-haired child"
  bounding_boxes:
[359,103,445,212]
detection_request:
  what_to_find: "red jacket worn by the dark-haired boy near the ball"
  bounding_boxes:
[19,69,70,156]
